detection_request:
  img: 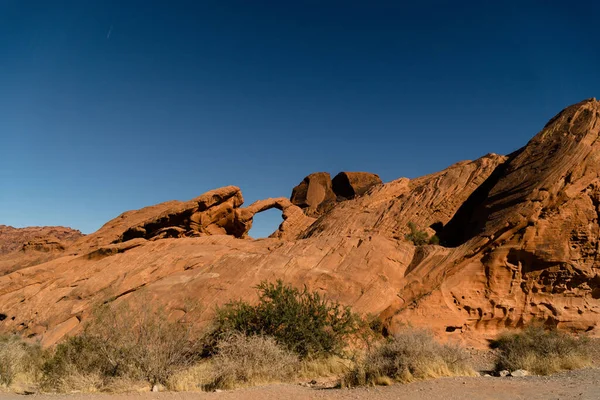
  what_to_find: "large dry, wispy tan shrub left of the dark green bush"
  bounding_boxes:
[43,306,198,391]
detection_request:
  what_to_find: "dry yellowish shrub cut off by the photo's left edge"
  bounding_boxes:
[0,335,43,386]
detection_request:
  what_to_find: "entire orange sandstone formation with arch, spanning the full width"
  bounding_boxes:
[0,99,600,345]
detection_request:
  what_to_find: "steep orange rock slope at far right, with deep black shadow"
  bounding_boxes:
[386,99,600,340]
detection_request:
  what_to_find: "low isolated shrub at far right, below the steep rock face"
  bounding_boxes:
[492,326,591,375]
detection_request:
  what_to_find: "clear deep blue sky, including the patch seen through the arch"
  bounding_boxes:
[0,0,600,236]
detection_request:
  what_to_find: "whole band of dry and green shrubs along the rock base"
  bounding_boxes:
[12,281,590,392]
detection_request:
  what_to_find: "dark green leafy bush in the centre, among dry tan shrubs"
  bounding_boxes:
[215,280,359,358]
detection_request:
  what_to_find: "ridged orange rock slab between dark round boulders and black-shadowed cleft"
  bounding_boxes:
[303,154,506,240]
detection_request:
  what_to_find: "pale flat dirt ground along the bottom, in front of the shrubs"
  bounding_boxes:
[5,368,600,400]
